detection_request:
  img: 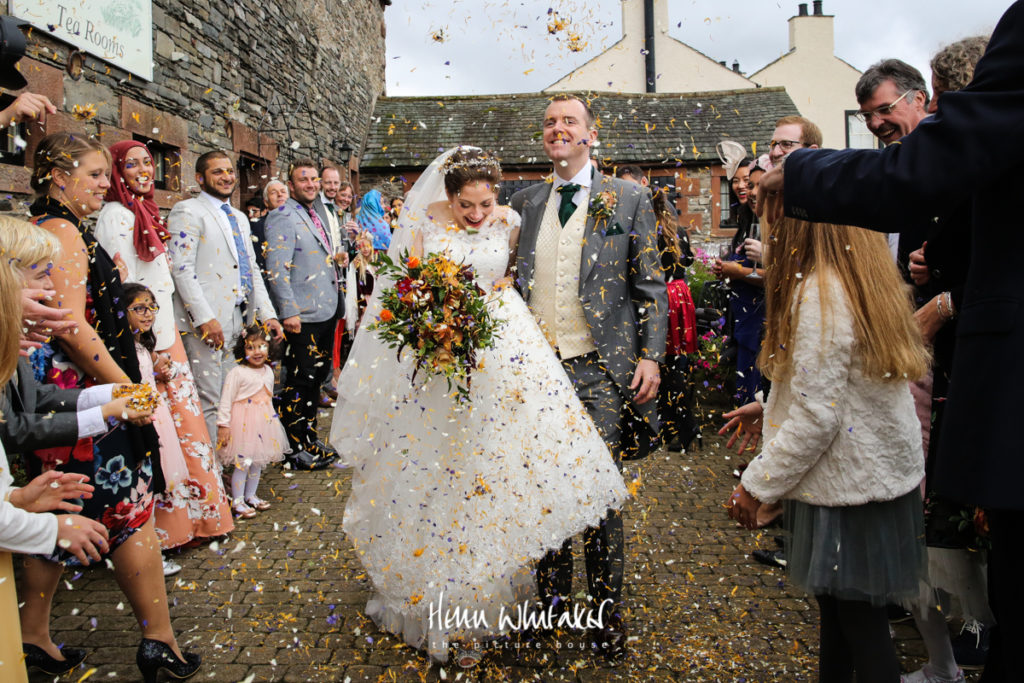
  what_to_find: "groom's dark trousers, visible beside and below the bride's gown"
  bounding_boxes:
[537,353,625,616]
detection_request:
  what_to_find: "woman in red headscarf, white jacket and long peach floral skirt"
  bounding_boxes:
[94,140,233,570]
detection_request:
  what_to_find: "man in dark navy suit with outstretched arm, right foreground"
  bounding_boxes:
[761,5,1024,683]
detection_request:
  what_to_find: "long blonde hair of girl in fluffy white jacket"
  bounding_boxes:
[758,218,929,381]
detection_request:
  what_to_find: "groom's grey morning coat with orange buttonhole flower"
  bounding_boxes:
[511,171,669,444]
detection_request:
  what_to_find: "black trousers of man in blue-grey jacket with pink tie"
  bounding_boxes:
[278,318,335,451]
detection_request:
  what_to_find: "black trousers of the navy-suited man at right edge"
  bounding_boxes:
[981,510,1024,683]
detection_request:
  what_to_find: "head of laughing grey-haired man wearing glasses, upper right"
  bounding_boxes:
[855,59,928,144]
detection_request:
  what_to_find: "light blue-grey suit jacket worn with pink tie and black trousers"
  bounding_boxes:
[266,199,339,323]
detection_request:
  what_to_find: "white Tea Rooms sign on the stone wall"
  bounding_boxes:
[9,0,153,81]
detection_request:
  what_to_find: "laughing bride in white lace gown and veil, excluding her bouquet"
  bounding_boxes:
[331,146,627,667]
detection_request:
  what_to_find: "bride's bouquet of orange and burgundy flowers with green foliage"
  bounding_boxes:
[369,252,499,400]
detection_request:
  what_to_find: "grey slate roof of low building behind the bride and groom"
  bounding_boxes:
[359,87,799,173]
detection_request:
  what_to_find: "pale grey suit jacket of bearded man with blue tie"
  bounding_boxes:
[167,192,278,332]
